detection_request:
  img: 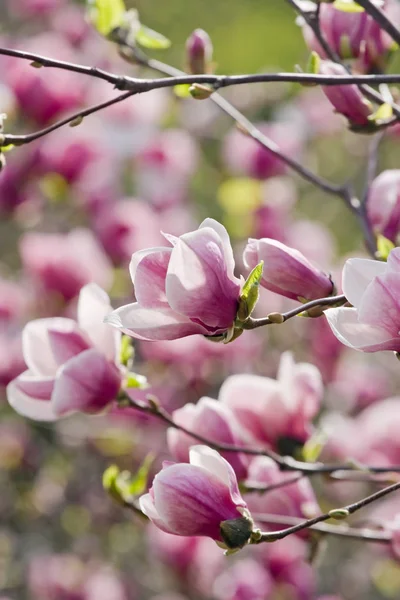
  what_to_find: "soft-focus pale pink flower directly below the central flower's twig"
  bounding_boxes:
[219,352,323,448]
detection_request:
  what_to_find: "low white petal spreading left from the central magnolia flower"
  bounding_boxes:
[106,302,208,341]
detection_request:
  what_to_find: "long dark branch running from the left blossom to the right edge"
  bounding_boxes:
[118,391,400,476]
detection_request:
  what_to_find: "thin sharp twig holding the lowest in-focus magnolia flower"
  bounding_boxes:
[257,482,400,543]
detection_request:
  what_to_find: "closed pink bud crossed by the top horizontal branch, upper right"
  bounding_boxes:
[319,60,374,128]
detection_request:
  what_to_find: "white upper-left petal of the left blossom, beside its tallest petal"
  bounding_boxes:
[22,318,75,376]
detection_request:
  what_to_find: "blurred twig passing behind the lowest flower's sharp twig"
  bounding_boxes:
[252,513,392,544]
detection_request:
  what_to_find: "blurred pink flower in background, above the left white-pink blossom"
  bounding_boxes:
[20,228,113,301]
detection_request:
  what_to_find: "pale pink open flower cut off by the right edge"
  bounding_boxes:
[324,248,400,352]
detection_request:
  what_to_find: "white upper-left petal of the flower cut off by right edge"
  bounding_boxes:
[342,258,387,308]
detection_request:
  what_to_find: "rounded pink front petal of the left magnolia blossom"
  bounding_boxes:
[52,348,121,416]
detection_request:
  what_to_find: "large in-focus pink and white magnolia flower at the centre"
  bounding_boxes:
[107,219,241,340]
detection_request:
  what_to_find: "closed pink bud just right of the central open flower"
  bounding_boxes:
[243,238,333,301]
